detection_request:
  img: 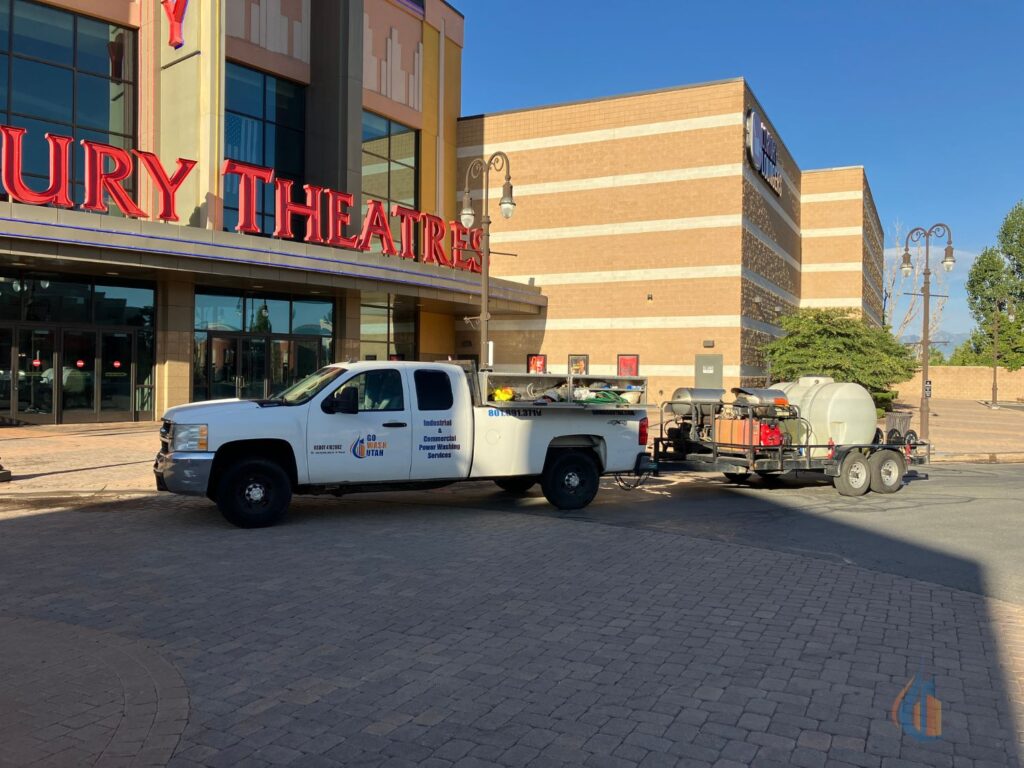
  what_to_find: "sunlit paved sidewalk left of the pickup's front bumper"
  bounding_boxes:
[0,422,160,504]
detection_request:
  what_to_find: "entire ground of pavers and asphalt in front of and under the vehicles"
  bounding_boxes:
[0,466,1024,768]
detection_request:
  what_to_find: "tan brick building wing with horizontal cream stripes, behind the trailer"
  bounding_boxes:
[459,80,883,396]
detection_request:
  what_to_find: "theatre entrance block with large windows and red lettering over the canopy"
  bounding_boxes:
[0,0,545,423]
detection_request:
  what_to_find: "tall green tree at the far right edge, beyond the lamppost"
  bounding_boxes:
[952,243,1024,371]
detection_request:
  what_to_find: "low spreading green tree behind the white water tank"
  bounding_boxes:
[765,309,918,392]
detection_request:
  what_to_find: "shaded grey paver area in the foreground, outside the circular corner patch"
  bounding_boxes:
[0,496,1017,768]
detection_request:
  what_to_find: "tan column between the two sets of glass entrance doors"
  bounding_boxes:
[156,275,196,418]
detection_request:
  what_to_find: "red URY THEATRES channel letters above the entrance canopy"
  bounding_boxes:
[0,123,483,272]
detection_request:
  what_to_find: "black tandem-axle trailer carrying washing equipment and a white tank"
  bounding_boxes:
[652,376,928,496]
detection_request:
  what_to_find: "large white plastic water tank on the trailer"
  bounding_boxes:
[772,376,878,457]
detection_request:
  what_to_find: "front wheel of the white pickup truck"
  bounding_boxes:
[217,459,292,528]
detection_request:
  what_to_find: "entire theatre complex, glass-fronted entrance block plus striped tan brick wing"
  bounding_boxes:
[0,0,882,423]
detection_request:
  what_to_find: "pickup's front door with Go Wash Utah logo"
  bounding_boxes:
[306,368,413,484]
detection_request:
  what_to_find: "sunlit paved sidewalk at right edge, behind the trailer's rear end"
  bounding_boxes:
[897,398,1024,463]
